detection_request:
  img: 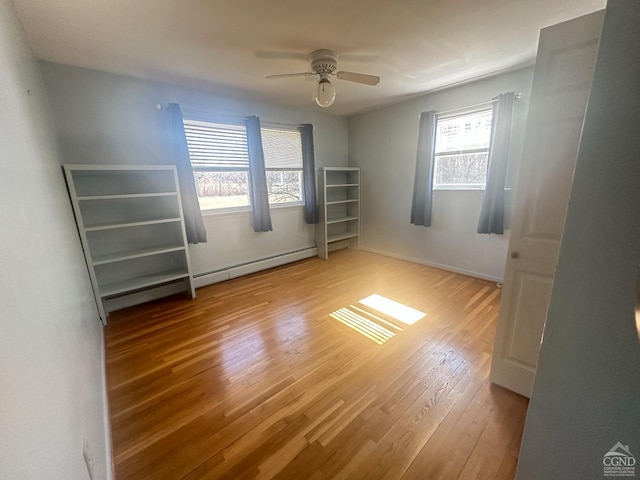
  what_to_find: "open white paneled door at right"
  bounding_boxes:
[491,12,604,397]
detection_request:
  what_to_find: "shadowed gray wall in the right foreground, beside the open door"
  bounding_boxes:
[517,0,640,480]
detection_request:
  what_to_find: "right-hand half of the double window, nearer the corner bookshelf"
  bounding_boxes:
[260,127,303,205]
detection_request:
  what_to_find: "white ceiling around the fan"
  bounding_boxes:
[14,0,606,115]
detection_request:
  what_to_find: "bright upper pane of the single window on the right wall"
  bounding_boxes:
[436,110,493,153]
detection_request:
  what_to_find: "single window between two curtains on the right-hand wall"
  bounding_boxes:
[433,110,493,189]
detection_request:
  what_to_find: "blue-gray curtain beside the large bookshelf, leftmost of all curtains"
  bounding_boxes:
[167,103,207,243]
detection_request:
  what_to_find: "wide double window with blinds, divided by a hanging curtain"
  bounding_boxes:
[184,119,303,210]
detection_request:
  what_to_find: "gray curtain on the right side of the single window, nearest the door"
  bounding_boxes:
[478,92,515,235]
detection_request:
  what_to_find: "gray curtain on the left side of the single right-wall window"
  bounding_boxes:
[411,110,438,227]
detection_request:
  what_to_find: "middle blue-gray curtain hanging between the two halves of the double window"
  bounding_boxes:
[244,115,273,232]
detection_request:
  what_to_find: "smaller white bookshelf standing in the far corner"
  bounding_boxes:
[316,167,360,260]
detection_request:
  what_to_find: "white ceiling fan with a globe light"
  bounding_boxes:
[265,49,380,108]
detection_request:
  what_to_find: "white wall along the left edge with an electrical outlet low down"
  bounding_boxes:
[0,0,110,480]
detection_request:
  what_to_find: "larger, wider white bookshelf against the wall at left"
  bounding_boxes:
[63,165,195,324]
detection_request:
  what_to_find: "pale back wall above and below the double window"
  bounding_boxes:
[41,62,348,274]
